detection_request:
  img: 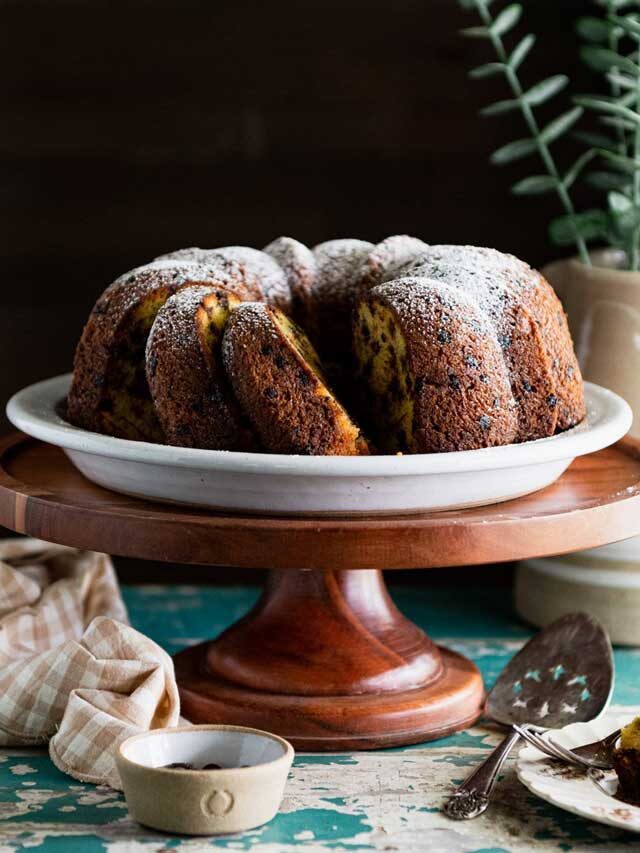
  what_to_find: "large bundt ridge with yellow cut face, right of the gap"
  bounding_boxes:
[355,277,517,453]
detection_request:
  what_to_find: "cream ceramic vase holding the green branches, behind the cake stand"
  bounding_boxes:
[515,250,640,645]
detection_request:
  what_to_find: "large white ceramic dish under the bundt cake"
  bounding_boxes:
[7,375,632,515]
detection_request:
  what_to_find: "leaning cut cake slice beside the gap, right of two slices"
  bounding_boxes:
[222,303,368,456]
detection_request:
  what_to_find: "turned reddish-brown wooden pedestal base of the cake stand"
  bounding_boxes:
[175,570,484,751]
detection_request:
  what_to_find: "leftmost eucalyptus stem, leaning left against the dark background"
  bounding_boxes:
[460,0,591,266]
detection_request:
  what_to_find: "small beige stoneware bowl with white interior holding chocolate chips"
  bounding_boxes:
[116,726,294,835]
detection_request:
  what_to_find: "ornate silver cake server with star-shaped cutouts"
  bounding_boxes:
[443,613,613,820]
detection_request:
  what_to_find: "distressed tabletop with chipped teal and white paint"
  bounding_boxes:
[0,583,640,853]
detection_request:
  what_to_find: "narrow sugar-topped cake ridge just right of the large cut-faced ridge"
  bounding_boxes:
[398,246,558,441]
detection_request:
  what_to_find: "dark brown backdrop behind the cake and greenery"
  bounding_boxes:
[0,0,591,584]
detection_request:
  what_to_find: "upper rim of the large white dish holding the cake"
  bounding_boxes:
[6,373,633,477]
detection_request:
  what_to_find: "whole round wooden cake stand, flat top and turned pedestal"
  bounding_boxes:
[0,434,640,750]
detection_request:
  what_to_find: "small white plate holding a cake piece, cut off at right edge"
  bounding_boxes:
[516,713,640,832]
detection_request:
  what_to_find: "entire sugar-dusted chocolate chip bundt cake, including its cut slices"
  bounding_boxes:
[68,235,585,455]
